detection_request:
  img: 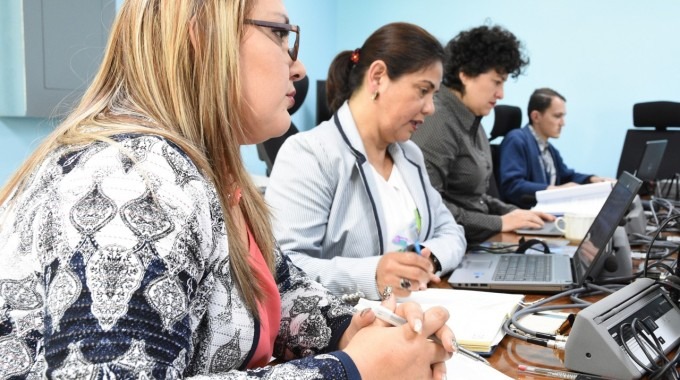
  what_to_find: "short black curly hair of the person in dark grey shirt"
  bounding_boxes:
[442,26,529,93]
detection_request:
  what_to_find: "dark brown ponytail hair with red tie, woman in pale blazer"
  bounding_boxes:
[326,22,444,112]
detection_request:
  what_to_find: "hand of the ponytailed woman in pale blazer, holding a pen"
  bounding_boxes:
[375,248,439,297]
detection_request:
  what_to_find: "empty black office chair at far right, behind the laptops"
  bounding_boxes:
[616,101,680,182]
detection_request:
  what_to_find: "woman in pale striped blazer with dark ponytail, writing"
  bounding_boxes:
[265,23,466,301]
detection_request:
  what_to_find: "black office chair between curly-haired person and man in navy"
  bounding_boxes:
[487,104,522,198]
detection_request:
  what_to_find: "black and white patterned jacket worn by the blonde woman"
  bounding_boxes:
[0,135,359,379]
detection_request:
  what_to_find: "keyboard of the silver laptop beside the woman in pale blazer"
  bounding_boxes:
[493,255,552,281]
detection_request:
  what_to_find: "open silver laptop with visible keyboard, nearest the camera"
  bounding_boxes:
[448,172,642,292]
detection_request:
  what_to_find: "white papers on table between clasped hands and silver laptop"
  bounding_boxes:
[358,289,524,354]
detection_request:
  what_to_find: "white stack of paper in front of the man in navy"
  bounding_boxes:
[532,182,614,215]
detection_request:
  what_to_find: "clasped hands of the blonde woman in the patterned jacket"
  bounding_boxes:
[344,296,455,379]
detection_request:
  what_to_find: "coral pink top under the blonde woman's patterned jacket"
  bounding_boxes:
[248,229,281,368]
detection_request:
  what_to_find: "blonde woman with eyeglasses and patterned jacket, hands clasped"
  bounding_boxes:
[0,0,454,379]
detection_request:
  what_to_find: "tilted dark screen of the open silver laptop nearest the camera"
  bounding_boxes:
[573,171,642,286]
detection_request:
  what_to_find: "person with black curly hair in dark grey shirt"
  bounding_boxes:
[411,26,554,244]
